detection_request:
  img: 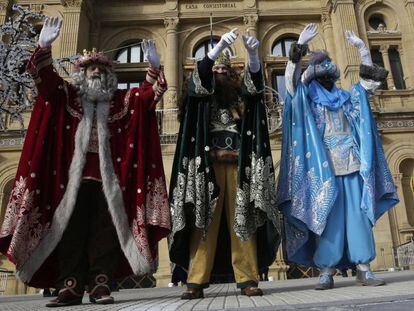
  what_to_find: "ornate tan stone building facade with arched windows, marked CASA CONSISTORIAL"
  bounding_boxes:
[0,0,414,293]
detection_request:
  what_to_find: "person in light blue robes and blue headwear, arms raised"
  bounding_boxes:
[277,26,398,276]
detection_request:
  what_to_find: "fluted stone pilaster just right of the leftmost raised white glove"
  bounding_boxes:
[60,0,84,57]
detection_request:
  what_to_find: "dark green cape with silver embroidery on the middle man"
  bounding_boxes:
[169,64,279,268]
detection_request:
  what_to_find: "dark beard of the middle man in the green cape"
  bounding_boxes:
[214,72,240,108]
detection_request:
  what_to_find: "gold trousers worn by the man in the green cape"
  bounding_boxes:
[187,162,259,288]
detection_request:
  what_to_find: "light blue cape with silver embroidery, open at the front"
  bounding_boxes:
[277,83,398,266]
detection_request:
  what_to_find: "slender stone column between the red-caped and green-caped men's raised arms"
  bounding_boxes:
[164,17,180,108]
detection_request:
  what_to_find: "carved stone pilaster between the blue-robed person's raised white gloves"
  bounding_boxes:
[331,0,360,88]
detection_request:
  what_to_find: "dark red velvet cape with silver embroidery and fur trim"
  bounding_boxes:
[0,48,170,287]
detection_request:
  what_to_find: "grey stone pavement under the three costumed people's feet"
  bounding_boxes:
[0,271,414,311]
